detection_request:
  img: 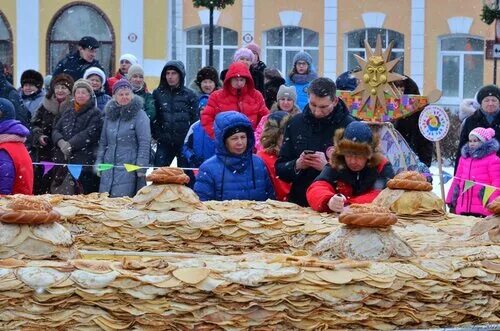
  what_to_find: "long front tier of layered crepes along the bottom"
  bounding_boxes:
[0,250,500,330]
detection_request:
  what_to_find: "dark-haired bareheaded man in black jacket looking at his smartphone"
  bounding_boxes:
[276,77,355,207]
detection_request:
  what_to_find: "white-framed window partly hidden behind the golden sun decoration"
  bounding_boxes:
[344,28,405,74]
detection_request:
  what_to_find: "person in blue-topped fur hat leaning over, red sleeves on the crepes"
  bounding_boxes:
[306,122,394,212]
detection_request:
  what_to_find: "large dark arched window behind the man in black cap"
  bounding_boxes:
[47,5,115,74]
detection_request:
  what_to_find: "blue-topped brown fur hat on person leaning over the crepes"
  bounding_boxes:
[330,121,383,169]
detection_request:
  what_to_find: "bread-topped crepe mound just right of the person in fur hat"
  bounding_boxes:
[373,171,447,221]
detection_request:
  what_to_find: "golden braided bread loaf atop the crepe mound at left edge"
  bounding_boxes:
[0,196,61,225]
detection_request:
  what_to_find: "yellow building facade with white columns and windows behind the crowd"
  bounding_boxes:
[0,0,495,105]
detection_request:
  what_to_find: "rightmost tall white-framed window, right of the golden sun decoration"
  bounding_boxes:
[438,35,484,104]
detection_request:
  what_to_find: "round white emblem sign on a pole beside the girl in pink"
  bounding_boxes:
[418,106,450,212]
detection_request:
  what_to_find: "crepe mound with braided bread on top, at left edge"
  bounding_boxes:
[0,195,78,260]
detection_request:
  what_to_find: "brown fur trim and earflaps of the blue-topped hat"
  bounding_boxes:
[330,129,384,170]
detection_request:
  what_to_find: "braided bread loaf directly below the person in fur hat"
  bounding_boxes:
[339,204,398,228]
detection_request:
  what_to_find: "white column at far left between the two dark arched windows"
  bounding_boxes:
[14,0,39,86]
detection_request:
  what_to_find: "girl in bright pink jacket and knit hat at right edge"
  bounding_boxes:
[446,127,500,217]
